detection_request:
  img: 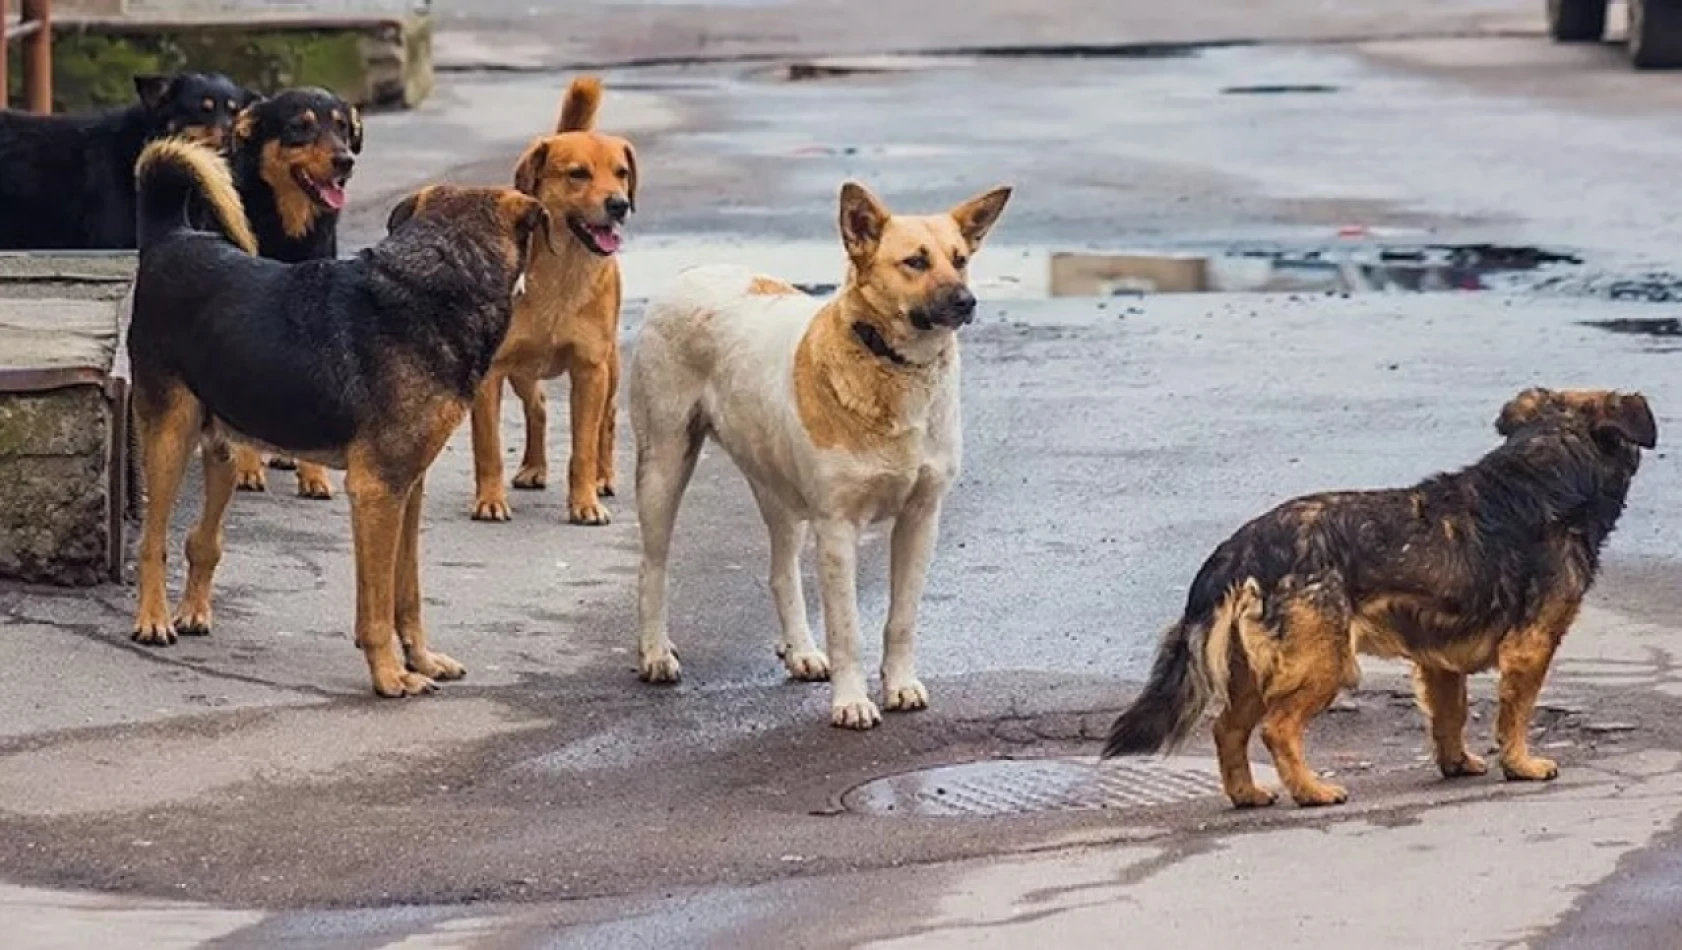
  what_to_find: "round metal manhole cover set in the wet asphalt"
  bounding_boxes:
[841,757,1277,817]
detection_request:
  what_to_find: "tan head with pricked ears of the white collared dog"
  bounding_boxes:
[841,182,1011,345]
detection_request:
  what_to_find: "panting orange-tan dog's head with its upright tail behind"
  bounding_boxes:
[515,77,636,257]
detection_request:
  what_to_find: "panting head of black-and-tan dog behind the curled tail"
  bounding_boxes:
[234,89,362,237]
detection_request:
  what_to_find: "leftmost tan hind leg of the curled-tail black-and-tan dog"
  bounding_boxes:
[133,383,200,646]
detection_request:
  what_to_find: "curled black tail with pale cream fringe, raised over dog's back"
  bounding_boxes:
[135,138,257,254]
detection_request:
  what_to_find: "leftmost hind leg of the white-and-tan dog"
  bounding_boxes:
[636,422,706,683]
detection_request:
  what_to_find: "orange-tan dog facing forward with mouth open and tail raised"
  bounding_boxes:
[473,77,636,525]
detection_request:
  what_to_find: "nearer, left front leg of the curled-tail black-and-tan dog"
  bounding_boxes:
[345,457,437,696]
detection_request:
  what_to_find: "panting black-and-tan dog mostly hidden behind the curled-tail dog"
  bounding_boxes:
[218,89,362,499]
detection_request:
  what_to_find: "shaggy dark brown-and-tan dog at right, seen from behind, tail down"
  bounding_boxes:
[1103,388,1658,807]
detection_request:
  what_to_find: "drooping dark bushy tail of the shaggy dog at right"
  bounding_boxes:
[1103,577,1262,758]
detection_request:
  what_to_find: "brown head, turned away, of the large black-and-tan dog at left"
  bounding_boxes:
[385,185,555,299]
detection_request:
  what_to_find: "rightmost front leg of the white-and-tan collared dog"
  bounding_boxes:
[881,494,940,711]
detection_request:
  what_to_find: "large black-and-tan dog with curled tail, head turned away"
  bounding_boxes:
[128,140,550,696]
